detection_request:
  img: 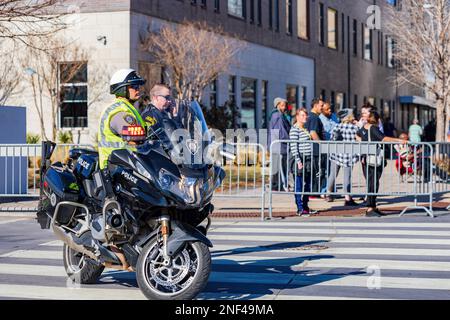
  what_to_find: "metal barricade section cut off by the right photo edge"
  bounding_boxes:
[430,142,450,210]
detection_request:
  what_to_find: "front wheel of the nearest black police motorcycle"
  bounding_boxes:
[136,239,211,300]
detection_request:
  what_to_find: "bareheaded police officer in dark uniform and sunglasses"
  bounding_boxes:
[142,84,176,147]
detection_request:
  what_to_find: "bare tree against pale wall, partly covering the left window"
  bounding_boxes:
[22,36,109,140]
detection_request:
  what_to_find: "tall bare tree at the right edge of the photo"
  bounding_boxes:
[386,0,450,141]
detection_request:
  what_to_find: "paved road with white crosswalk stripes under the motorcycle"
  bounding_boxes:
[0,216,450,300]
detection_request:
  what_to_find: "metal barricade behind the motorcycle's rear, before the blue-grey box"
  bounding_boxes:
[0,144,93,209]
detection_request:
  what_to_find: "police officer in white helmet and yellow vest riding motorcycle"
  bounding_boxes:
[98,69,146,171]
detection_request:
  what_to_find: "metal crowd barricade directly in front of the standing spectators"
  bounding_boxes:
[268,140,434,218]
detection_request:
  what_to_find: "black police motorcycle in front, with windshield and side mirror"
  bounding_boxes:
[38,102,233,300]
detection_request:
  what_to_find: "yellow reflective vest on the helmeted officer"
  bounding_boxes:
[98,98,147,169]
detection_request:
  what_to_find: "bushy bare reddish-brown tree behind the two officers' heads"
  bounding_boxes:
[143,22,244,100]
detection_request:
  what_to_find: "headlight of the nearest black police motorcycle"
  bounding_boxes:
[159,169,199,204]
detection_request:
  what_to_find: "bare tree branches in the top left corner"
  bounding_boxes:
[0,0,70,46]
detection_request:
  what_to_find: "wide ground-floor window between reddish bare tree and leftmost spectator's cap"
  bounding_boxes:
[241,78,256,129]
